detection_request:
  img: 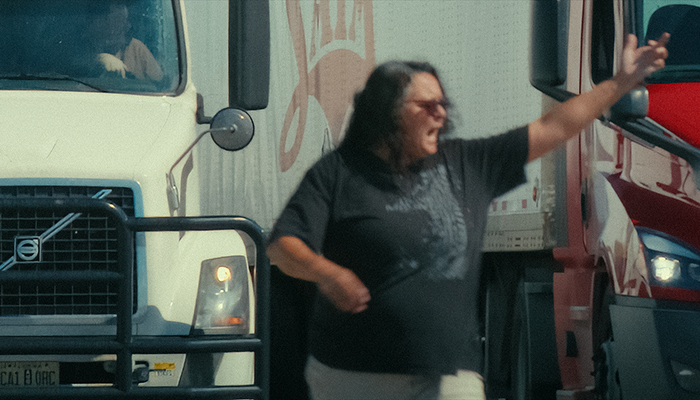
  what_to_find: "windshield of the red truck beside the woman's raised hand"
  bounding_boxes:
[637,0,700,83]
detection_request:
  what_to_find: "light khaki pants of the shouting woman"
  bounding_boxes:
[305,357,486,400]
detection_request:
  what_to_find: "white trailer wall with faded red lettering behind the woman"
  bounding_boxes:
[185,0,541,228]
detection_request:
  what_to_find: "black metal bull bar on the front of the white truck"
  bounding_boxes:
[0,199,270,400]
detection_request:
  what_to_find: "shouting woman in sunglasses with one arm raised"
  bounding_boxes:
[268,35,668,400]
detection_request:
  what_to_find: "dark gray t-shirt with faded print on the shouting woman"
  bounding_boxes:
[270,127,528,374]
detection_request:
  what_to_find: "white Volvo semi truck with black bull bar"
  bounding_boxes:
[0,0,269,399]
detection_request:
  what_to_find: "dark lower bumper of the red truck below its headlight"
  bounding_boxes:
[610,296,700,400]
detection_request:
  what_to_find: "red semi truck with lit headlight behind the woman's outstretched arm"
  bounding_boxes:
[485,0,700,400]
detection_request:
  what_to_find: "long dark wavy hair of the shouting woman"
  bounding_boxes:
[341,61,451,170]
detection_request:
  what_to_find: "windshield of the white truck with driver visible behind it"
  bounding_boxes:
[0,0,180,93]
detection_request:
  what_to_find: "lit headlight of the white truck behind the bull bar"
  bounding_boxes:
[194,256,250,334]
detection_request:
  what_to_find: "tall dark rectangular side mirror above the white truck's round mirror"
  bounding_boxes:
[228,0,270,110]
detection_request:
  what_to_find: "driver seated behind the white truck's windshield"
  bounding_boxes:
[87,1,163,82]
